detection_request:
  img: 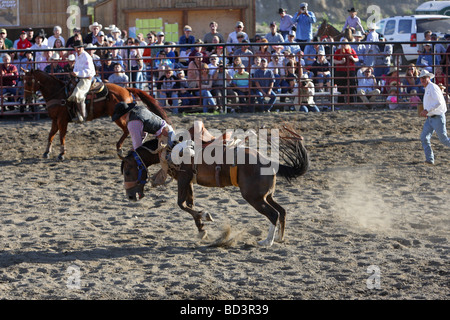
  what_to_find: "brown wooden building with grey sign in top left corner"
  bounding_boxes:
[0,0,71,40]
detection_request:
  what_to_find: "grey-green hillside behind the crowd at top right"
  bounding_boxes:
[256,0,425,29]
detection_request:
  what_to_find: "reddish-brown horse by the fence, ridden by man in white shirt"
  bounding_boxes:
[23,70,170,160]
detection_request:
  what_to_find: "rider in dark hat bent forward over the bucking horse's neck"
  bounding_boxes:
[111,102,175,185]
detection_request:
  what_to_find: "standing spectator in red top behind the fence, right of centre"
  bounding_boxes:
[334,38,359,102]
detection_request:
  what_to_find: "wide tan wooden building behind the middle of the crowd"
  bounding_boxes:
[94,0,256,42]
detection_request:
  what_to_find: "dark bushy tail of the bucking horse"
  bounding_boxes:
[277,139,309,182]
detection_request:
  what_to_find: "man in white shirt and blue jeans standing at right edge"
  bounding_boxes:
[419,70,450,165]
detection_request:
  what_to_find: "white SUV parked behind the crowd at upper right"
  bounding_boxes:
[376,14,450,65]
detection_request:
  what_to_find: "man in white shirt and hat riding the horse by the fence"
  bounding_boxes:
[67,40,96,122]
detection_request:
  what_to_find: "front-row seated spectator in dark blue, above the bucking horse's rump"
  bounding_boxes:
[253,58,277,111]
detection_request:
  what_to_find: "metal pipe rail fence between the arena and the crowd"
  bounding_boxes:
[0,41,450,118]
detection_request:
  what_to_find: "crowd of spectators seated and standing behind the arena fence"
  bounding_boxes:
[0,3,450,113]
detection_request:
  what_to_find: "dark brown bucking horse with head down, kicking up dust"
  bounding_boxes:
[121,124,309,246]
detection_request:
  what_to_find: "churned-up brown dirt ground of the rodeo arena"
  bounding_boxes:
[0,110,450,300]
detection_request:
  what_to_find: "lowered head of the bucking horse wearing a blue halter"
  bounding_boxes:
[121,139,159,201]
